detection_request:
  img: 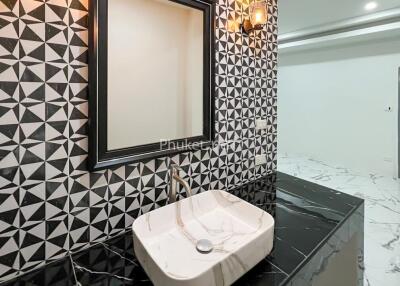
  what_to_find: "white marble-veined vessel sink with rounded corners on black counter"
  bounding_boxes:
[132,191,274,286]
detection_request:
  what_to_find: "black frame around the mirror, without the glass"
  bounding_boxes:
[88,0,215,171]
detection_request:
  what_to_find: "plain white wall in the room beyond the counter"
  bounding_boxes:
[278,39,400,176]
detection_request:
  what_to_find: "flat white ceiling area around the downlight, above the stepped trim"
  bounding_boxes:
[278,0,400,34]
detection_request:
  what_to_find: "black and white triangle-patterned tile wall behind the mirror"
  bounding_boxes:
[0,0,277,280]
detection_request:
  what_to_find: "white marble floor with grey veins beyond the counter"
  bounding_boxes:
[278,154,400,286]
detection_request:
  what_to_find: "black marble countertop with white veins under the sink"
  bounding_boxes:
[2,173,363,286]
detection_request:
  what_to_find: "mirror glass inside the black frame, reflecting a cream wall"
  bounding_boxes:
[107,0,204,150]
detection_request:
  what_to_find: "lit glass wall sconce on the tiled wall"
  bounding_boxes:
[242,1,268,34]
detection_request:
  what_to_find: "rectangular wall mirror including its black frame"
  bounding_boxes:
[89,0,215,170]
